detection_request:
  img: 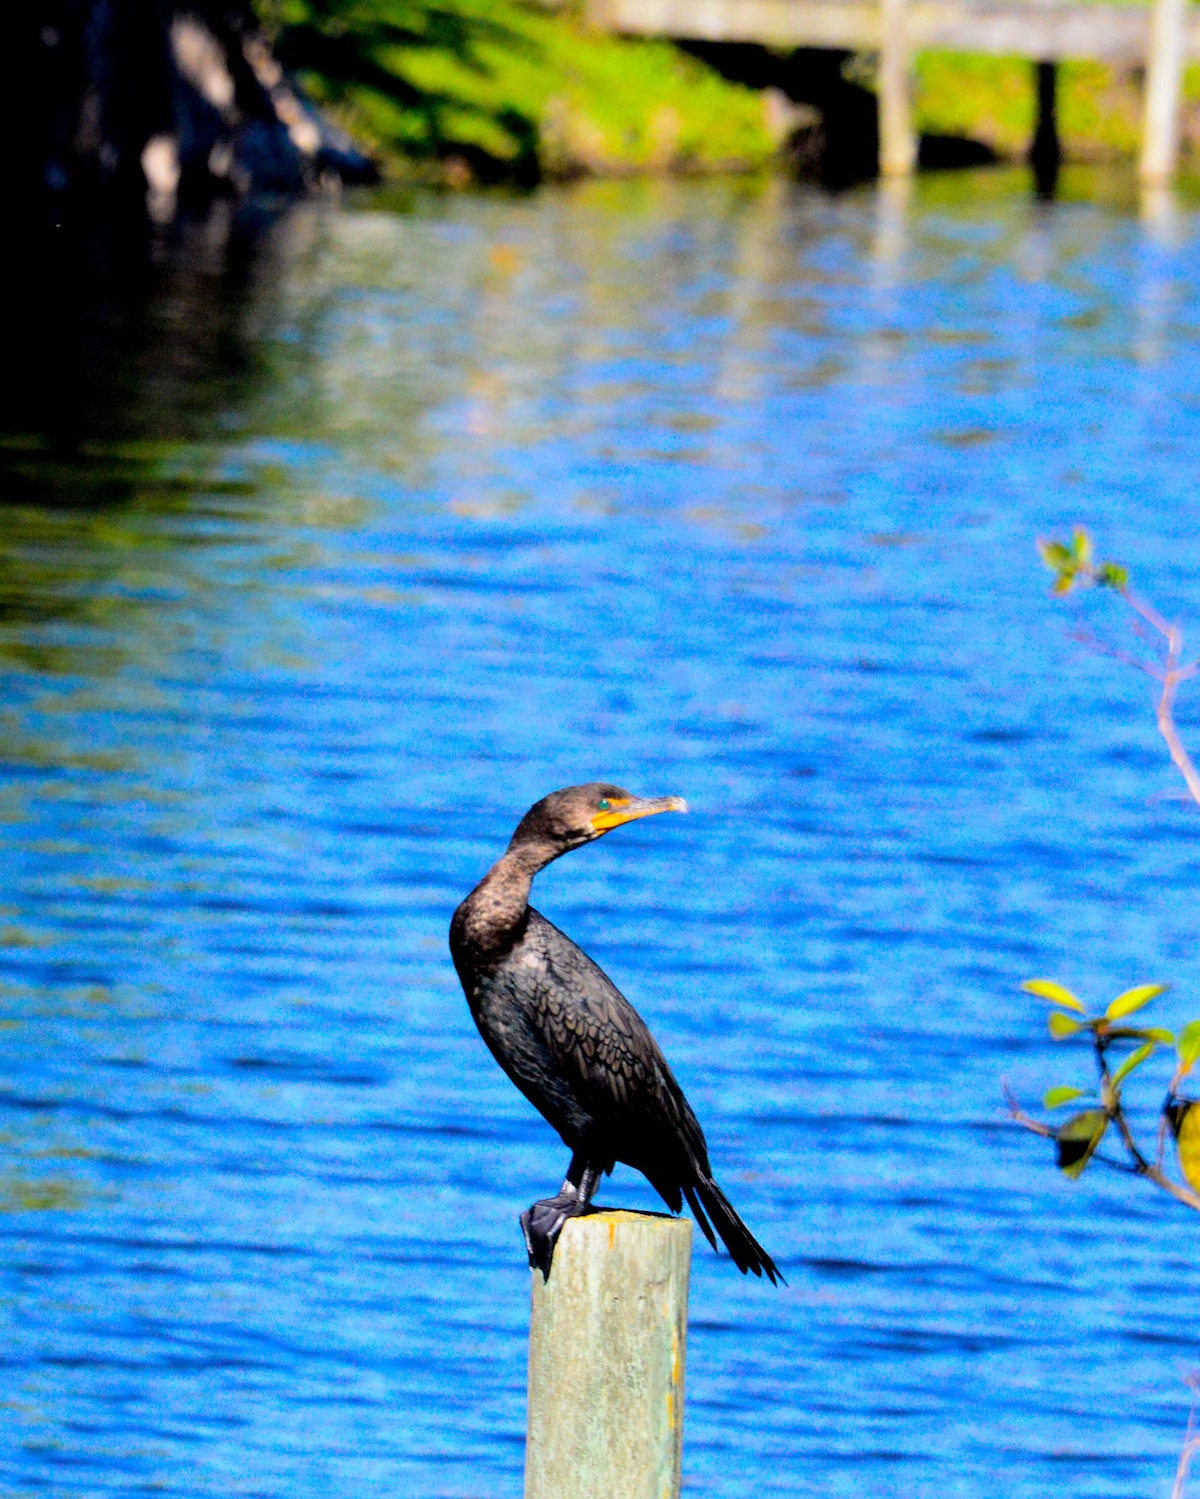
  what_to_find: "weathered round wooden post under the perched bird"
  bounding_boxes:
[524,1211,692,1499]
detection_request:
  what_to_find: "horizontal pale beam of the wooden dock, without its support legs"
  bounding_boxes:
[589,0,1200,63]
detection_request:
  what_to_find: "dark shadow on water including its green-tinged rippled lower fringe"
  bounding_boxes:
[0,202,304,675]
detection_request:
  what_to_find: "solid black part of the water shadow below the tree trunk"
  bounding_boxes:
[0,202,286,494]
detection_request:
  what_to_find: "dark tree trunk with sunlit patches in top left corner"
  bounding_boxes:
[0,0,373,223]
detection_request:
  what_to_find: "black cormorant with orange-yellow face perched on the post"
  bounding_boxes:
[449,782,782,1283]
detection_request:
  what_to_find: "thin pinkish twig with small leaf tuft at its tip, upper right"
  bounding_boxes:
[1038,526,1200,805]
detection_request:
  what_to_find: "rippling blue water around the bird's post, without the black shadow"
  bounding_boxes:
[0,174,1200,1499]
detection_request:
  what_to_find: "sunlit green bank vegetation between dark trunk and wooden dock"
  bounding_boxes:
[261,0,779,181]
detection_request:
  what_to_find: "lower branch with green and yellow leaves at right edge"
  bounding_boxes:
[1004,979,1200,1213]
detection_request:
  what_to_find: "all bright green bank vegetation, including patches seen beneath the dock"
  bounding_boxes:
[258,0,1200,181]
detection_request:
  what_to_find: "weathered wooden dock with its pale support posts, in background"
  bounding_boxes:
[589,0,1200,184]
